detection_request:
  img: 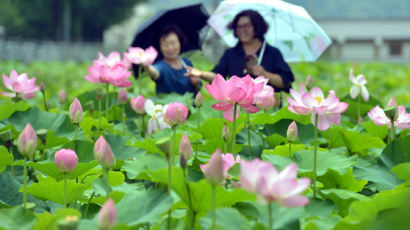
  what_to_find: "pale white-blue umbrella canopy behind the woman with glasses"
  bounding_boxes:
[208,0,332,62]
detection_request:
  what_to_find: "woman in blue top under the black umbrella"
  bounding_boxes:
[143,25,201,94]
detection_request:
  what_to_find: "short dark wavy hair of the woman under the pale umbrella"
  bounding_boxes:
[227,10,269,41]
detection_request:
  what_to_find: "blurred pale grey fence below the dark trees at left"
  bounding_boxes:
[0,38,122,63]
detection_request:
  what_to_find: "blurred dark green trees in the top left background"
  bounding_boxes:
[0,0,144,41]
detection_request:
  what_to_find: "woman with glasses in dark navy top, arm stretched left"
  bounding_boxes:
[186,10,294,92]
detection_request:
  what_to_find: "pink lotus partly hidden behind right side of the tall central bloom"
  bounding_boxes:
[253,76,275,109]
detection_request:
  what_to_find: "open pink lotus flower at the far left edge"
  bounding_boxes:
[0,70,39,98]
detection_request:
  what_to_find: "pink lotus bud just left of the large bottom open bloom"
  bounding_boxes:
[200,149,224,186]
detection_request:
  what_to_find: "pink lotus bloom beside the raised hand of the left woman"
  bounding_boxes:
[124,46,158,66]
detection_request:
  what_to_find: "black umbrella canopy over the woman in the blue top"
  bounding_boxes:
[131,3,209,53]
